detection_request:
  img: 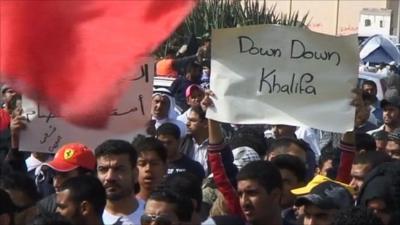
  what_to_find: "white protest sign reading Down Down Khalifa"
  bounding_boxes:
[207,25,359,132]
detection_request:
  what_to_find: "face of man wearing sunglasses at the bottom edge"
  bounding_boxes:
[141,199,179,225]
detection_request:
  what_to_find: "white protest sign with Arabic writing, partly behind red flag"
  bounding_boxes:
[20,60,154,153]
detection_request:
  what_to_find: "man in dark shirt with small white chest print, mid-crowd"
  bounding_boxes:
[156,123,205,181]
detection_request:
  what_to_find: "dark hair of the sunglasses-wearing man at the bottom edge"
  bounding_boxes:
[147,187,193,222]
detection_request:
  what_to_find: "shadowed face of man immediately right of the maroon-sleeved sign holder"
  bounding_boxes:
[279,169,302,209]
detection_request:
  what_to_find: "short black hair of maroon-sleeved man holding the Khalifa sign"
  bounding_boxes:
[236,161,282,193]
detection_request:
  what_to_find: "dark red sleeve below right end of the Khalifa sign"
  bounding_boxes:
[336,142,355,184]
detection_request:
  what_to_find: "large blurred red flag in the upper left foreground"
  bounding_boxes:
[0,0,196,127]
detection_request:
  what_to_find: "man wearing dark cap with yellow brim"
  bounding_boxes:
[292,175,353,225]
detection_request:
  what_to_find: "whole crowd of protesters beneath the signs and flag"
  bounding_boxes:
[0,39,400,225]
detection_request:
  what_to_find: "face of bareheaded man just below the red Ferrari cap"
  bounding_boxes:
[56,189,84,224]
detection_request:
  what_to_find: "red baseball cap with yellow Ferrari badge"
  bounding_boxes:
[43,143,96,172]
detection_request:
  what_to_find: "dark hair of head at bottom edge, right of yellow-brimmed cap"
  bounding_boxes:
[333,207,383,225]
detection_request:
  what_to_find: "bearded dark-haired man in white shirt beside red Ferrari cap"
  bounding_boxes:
[95,140,145,225]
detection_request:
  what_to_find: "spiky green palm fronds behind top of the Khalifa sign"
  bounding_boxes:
[155,0,307,57]
